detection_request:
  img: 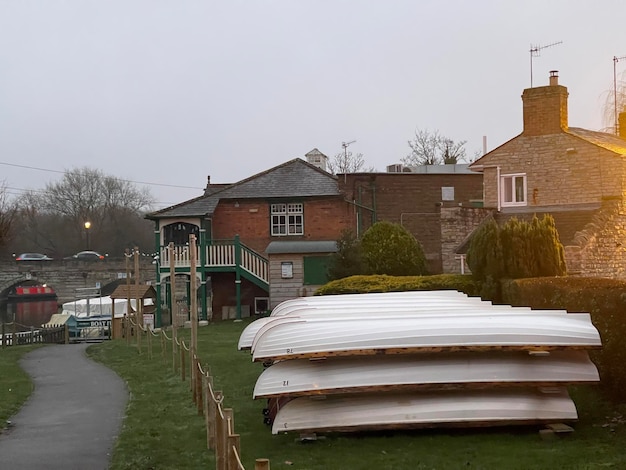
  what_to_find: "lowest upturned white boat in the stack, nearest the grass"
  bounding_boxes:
[272,388,578,434]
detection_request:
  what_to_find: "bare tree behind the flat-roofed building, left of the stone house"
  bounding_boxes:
[402,129,466,166]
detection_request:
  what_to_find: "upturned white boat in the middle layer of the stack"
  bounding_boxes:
[253,351,600,398]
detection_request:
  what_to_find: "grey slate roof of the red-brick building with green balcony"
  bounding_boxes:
[146,158,341,219]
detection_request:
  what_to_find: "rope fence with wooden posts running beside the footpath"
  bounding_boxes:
[124,315,270,470]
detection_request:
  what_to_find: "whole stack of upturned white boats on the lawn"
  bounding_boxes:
[239,291,601,434]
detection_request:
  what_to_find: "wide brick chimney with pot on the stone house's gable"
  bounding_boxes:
[522,70,569,135]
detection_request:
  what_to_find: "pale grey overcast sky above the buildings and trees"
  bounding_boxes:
[0,0,626,208]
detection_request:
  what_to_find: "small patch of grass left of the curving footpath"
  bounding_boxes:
[0,346,37,430]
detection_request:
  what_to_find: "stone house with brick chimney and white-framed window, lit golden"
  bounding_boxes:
[470,71,626,278]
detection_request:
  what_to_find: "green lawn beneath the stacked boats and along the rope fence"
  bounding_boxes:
[0,321,626,470]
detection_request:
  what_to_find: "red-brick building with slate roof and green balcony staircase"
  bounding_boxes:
[147,154,352,321]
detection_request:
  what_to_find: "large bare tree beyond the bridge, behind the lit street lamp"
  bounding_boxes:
[17,168,153,256]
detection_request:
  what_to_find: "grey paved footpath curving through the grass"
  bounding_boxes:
[0,344,128,470]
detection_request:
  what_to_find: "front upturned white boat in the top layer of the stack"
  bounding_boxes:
[252,313,601,362]
